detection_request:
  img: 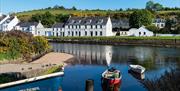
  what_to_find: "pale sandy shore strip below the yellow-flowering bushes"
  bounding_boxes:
[0,52,74,74]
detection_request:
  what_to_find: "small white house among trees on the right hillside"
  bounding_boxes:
[153,18,166,28]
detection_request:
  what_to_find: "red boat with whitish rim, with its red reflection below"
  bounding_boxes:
[101,68,122,91]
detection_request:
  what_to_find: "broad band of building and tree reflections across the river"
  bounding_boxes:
[52,44,180,70]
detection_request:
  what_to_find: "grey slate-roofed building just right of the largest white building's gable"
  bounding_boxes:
[111,18,130,29]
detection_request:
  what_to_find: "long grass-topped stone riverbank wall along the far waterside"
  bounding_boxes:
[48,36,180,47]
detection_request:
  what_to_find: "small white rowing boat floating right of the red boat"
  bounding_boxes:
[129,65,146,74]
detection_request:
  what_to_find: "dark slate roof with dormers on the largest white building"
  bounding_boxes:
[66,17,108,25]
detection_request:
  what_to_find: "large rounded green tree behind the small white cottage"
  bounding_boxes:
[129,10,153,28]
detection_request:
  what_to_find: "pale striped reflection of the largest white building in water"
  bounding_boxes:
[53,44,112,65]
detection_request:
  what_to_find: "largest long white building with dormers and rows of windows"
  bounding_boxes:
[65,17,115,36]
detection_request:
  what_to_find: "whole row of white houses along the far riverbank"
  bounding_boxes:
[0,14,165,36]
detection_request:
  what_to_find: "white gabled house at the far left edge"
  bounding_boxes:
[0,14,19,31]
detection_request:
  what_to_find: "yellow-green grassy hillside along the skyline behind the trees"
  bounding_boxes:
[16,8,180,21]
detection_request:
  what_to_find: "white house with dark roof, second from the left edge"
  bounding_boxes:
[14,22,44,36]
